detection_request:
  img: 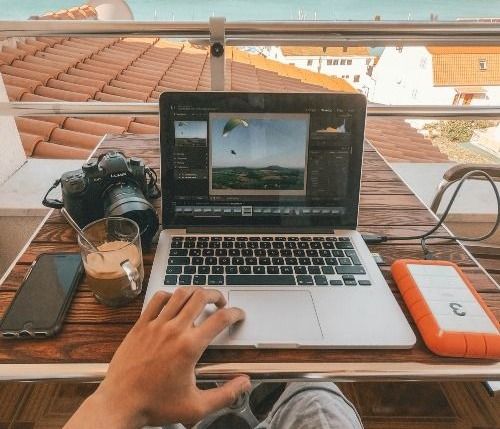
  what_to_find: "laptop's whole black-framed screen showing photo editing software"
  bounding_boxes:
[160,92,366,228]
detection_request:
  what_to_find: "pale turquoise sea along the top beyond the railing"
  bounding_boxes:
[0,0,500,21]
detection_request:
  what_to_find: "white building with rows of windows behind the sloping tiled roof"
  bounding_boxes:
[265,46,375,96]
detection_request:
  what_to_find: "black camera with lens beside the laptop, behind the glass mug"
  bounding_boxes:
[42,151,160,248]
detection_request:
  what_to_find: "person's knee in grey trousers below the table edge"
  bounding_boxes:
[256,382,363,429]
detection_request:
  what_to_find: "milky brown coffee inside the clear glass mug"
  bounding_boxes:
[85,241,141,279]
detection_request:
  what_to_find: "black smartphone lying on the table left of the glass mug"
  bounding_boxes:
[0,253,83,338]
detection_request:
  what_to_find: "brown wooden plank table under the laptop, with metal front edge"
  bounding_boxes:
[0,135,500,381]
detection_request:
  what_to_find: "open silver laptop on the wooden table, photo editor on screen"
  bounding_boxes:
[144,92,415,348]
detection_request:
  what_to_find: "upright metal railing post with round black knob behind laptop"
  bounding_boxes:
[208,17,226,91]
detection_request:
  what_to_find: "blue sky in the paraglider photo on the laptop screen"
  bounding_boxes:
[210,115,308,168]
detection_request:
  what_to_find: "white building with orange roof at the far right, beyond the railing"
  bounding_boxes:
[369,46,500,105]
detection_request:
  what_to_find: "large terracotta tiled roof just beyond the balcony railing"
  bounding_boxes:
[0,7,446,162]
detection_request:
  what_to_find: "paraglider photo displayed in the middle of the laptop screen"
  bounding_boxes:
[209,113,309,195]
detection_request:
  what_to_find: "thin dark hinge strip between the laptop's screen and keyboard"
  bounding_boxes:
[186,226,335,234]
